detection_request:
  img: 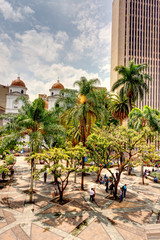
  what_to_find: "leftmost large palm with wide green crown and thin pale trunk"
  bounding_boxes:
[2,98,65,202]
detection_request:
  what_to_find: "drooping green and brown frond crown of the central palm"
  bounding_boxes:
[60,77,107,145]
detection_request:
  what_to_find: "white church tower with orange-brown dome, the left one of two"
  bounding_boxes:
[5,77,28,113]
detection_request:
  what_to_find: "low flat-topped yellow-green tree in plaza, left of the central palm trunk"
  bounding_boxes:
[33,144,85,202]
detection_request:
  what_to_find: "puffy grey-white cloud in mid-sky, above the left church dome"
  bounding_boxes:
[15,30,68,65]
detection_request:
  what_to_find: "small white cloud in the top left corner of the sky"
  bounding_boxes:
[0,0,34,22]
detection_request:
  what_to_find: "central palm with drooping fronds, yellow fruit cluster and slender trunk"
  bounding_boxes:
[58,77,100,190]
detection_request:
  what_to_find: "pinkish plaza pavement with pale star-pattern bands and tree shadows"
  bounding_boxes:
[0,157,160,240]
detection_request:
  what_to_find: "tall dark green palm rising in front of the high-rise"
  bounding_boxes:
[112,60,151,112]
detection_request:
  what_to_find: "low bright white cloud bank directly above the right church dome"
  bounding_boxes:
[22,64,102,100]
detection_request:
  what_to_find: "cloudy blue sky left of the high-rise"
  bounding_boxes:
[0,0,112,100]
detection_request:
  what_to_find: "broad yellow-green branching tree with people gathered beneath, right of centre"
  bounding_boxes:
[87,126,150,198]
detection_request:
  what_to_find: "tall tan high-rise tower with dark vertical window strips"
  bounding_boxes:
[111,0,160,110]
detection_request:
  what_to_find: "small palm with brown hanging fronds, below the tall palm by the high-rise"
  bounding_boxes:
[111,94,129,125]
